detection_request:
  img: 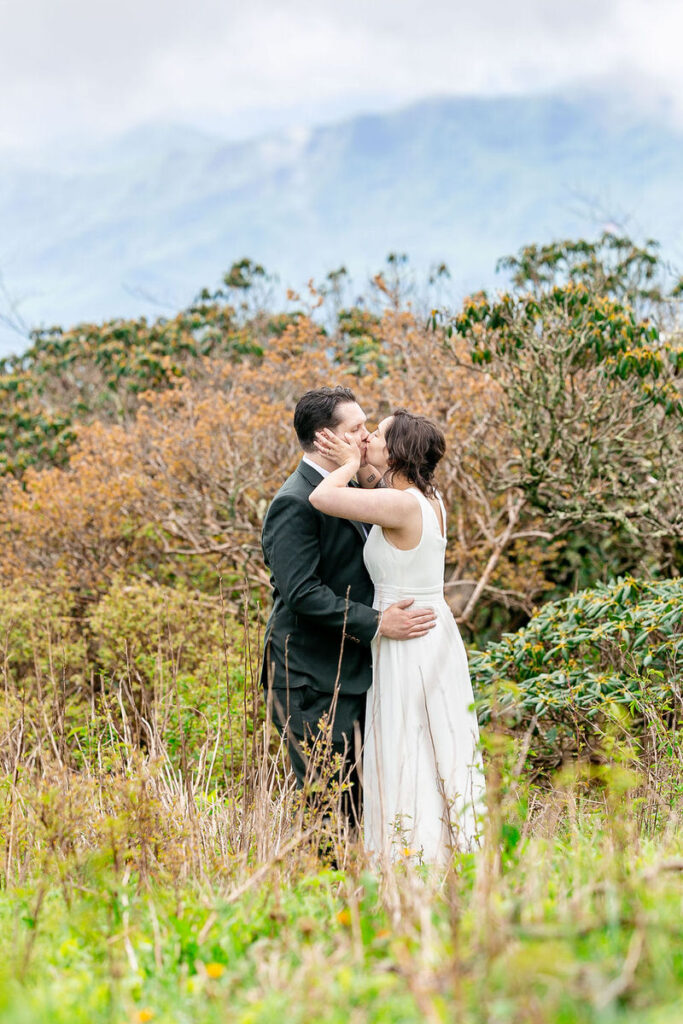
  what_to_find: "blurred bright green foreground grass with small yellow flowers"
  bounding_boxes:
[0,797,683,1024]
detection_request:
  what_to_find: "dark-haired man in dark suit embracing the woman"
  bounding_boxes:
[261,387,435,822]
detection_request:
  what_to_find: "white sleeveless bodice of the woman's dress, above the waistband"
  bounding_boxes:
[364,487,446,607]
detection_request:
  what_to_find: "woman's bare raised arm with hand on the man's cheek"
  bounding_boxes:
[308,431,422,529]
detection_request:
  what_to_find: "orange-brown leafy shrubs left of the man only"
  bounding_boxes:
[0,321,358,596]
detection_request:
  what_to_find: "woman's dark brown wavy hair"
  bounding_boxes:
[384,409,445,498]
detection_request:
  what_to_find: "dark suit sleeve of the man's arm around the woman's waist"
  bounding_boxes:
[263,497,379,644]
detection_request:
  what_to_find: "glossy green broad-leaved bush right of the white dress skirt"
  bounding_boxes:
[470,577,683,766]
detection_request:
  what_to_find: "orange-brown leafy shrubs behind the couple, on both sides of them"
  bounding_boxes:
[0,309,557,610]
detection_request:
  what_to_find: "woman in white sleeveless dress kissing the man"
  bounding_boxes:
[309,410,484,863]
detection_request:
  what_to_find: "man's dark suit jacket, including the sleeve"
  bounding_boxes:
[261,462,378,694]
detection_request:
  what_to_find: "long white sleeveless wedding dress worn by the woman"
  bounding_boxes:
[362,487,484,864]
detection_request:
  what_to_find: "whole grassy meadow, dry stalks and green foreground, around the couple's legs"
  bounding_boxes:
[0,610,683,1024]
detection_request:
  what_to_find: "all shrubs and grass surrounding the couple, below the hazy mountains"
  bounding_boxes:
[0,236,683,1024]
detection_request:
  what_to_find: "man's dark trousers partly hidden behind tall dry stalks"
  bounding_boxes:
[270,686,367,828]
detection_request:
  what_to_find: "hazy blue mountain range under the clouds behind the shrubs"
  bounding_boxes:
[0,96,683,352]
